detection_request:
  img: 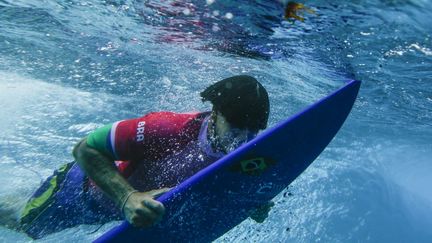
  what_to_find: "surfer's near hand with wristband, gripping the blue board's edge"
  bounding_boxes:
[123,188,170,227]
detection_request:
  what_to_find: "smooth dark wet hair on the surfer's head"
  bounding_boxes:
[201,75,270,131]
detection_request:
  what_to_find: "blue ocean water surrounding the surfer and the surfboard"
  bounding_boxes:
[0,0,432,242]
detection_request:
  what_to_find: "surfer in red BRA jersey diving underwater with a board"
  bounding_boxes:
[2,75,273,239]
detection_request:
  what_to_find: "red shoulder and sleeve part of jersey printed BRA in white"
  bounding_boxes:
[109,112,210,161]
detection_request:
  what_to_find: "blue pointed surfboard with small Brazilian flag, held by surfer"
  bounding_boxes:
[96,80,360,242]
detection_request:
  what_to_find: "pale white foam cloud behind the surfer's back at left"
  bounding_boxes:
[0,71,126,194]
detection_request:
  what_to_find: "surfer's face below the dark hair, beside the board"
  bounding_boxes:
[214,113,256,153]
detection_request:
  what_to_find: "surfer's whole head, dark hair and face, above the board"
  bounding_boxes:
[201,75,270,152]
